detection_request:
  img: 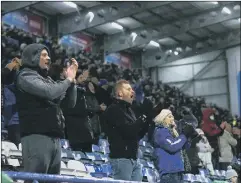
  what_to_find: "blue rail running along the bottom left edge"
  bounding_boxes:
[3,171,141,183]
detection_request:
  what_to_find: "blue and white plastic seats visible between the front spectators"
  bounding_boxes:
[2,139,233,183]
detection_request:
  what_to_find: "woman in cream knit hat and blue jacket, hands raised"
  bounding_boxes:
[152,109,196,183]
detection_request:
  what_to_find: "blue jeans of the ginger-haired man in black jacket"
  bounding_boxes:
[110,158,142,182]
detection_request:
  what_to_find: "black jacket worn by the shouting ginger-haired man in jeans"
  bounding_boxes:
[104,100,145,159]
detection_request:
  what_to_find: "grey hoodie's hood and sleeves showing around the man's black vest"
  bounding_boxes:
[17,44,77,103]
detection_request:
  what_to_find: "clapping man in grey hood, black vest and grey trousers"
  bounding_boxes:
[15,44,78,174]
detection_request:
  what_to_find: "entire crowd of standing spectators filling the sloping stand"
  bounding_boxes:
[1,25,240,183]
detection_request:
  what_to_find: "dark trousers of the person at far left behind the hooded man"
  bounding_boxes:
[7,124,21,147]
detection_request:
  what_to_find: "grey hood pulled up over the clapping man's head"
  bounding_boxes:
[22,43,50,67]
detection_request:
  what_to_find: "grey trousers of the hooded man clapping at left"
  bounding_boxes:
[21,134,61,174]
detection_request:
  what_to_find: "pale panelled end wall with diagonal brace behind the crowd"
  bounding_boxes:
[151,50,230,109]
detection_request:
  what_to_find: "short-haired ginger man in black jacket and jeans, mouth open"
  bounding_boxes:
[104,80,146,181]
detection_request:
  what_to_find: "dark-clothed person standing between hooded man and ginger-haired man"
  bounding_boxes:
[64,71,105,152]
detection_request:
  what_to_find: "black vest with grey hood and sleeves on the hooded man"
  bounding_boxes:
[15,44,76,138]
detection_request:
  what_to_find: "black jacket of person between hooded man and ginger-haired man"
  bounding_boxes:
[63,87,100,145]
